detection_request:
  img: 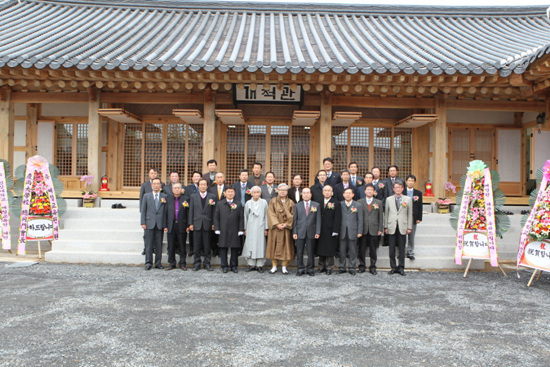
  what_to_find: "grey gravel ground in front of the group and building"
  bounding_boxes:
[0,263,550,367]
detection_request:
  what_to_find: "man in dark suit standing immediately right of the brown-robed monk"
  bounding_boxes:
[292,188,321,276]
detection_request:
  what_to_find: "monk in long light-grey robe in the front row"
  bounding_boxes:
[243,186,269,273]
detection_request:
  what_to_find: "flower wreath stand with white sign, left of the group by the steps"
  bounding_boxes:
[17,155,59,255]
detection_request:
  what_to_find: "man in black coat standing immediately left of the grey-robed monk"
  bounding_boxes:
[214,187,244,273]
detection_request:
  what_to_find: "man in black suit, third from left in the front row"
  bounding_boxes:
[188,179,216,271]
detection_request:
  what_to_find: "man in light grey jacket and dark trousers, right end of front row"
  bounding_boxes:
[384,180,413,275]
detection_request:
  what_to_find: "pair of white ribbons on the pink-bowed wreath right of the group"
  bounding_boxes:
[455,168,498,266]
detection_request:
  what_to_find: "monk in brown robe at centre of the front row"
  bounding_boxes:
[266,184,294,274]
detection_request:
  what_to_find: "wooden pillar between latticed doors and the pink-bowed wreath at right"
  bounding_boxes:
[433,95,447,198]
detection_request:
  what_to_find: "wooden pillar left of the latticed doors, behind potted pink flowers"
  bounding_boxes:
[88,91,103,189]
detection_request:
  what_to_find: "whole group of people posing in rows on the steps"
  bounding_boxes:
[140,157,422,276]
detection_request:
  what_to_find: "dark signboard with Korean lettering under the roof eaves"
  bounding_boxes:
[233,84,303,104]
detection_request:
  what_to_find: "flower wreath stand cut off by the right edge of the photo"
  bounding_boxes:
[517,160,550,286]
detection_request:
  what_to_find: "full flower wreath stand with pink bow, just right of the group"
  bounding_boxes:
[451,160,510,275]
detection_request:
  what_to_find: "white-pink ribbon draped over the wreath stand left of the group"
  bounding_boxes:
[17,155,59,255]
